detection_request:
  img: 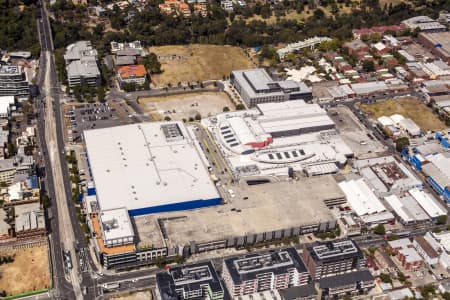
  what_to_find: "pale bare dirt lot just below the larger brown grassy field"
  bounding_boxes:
[139,92,234,121]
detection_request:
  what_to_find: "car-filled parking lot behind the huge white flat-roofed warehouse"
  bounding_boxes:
[64,102,131,144]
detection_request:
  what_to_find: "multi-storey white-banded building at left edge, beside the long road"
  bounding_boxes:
[0,65,30,98]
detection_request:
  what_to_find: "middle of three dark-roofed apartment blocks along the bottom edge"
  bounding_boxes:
[222,248,309,298]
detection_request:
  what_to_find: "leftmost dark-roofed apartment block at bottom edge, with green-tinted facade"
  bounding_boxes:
[156,262,225,300]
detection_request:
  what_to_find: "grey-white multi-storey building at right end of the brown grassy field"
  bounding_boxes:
[230,69,312,107]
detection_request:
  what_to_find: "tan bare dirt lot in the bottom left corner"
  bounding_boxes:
[0,246,50,295]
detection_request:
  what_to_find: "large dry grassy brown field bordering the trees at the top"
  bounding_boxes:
[149,45,254,86]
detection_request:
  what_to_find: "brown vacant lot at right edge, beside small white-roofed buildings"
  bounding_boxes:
[361,97,446,131]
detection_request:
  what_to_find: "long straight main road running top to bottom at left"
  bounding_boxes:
[36,2,95,299]
